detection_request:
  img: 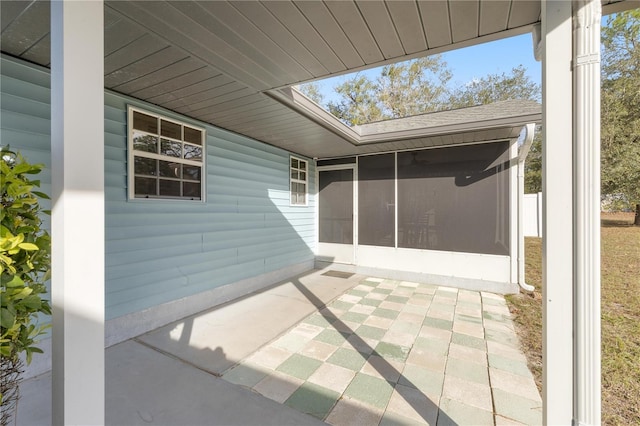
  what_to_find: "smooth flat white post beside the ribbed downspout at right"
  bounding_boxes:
[542,0,573,425]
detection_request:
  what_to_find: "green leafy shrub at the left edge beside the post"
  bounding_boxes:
[0,147,51,401]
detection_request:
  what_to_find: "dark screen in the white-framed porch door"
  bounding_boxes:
[318,169,353,244]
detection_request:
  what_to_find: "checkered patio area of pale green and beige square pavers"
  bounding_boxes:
[223,278,542,425]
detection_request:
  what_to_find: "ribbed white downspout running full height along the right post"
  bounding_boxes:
[573,0,602,425]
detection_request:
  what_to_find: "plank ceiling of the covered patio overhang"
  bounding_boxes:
[0,0,628,157]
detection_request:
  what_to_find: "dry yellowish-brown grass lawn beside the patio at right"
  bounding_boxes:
[507,213,640,425]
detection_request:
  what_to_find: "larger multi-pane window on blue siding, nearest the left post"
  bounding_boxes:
[129,107,205,200]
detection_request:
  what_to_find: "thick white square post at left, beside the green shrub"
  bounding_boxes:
[51,0,105,425]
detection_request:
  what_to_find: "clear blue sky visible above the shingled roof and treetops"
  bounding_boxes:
[317,33,542,101]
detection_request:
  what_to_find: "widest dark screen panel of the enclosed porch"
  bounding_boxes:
[398,142,509,255]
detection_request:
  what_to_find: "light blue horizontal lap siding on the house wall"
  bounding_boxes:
[1,57,315,319]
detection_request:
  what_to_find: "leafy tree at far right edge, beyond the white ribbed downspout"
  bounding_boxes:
[601,9,640,216]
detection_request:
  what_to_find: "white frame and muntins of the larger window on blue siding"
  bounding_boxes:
[127,106,206,203]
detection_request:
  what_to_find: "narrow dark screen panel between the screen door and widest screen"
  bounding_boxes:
[358,153,396,247]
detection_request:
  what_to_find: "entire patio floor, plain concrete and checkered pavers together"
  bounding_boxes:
[17,271,542,425]
